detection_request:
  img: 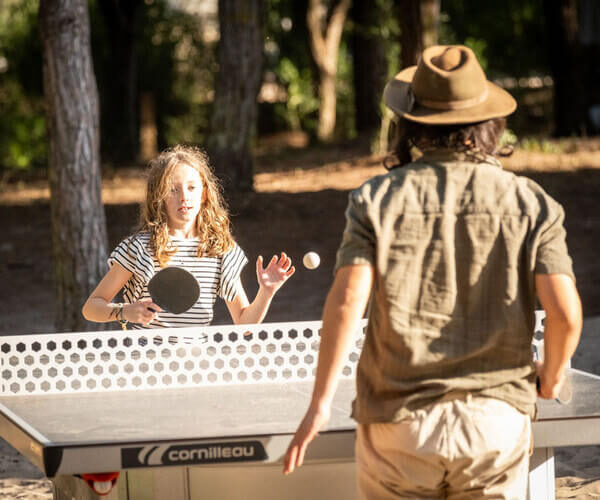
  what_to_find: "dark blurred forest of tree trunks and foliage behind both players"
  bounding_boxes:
[0,0,600,331]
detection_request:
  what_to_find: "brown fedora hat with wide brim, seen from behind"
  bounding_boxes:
[383,45,517,125]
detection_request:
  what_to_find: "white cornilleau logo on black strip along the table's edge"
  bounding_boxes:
[121,441,267,468]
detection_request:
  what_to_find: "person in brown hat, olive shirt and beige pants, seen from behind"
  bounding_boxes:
[284,46,581,500]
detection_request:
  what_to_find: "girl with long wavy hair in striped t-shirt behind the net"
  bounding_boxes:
[82,146,295,328]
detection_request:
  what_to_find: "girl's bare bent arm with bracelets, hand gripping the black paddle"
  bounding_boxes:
[81,262,162,324]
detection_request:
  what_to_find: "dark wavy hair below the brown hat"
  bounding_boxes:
[384,116,512,170]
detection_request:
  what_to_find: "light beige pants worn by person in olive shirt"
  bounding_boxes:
[356,394,531,500]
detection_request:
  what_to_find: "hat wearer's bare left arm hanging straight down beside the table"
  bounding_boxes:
[283,265,373,474]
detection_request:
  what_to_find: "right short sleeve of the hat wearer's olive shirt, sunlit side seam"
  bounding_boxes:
[535,196,575,279]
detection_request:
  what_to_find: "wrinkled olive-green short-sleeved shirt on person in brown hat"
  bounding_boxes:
[336,150,573,423]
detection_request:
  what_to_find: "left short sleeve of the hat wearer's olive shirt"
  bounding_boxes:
[334,190,375,271]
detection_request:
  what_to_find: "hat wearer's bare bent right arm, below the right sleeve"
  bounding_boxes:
[535,274,582,399]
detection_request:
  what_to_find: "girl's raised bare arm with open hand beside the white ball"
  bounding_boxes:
[226,253,296,324]
